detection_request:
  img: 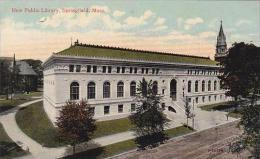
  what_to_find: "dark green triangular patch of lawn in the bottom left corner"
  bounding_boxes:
[0,124,28,159]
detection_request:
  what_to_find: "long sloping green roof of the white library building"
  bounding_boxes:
[55,44,217,65]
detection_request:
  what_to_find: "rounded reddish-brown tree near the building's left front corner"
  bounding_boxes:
[56,100,96,154]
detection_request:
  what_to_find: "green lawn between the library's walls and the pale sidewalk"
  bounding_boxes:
[15,102,131,147]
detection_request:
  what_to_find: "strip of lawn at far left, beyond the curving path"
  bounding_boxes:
[0,92,42,113]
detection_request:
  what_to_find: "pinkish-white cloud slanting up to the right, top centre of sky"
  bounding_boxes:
[125,10,154,26]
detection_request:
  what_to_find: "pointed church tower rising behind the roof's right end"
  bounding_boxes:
[215,21,227,62]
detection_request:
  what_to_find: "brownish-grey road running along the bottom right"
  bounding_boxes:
[114,121,247,159]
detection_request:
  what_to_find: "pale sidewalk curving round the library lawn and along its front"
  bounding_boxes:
[0,99,239,159]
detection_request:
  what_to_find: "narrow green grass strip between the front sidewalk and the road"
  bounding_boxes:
[65,126,192,159]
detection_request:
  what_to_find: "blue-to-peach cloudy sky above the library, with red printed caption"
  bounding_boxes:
[0,0,260,61]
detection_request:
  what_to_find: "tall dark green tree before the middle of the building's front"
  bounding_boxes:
[129,78,167,149]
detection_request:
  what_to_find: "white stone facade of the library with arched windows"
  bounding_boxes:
[44,55,231,121]
